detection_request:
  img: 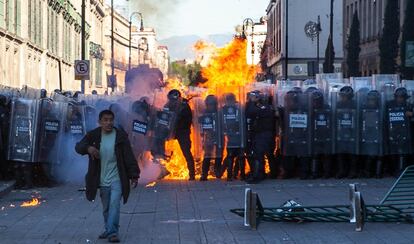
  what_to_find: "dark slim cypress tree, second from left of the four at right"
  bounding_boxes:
[346,12,361,77]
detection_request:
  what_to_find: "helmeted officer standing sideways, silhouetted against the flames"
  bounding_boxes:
[166,89,195,180]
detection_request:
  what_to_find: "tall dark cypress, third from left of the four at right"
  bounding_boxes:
[379,1,400,74]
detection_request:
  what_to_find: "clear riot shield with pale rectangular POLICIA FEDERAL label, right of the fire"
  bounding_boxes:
[282,91,311,156]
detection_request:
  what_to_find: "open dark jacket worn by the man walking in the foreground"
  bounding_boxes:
[75,127,140,204]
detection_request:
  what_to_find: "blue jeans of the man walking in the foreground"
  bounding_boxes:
[100,181,122,236]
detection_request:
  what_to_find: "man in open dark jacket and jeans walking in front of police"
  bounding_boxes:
[75,110,140,242]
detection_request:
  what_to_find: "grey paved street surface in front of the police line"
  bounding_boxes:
[0,178,414,244]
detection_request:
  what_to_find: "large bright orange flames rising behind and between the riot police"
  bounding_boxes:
[157,38,260,180]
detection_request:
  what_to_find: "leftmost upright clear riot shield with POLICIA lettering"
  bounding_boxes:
[7,98,38,162]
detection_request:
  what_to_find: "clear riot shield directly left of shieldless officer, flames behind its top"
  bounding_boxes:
[217,87,245,148]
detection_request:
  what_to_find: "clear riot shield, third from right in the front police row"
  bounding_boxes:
[331,87,358,154]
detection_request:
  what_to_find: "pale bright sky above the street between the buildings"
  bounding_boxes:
[111,0,270,39]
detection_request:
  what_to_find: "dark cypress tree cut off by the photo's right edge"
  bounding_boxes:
[400,1,414,79]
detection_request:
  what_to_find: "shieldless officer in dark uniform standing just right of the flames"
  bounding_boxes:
[246,91,277,183]
